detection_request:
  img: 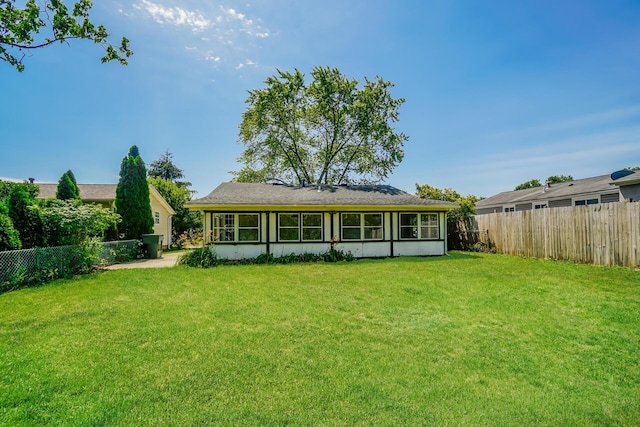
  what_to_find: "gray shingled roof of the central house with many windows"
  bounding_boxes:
[187,182,456,208]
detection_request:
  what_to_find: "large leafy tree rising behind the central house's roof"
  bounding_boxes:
[234,67,408,184]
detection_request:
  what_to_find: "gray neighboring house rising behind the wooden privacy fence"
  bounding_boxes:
[476,171,640,215]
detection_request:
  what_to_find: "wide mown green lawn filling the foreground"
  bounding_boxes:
[0,253,640,426]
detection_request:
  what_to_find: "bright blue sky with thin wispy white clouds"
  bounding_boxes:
[0,0,640,197]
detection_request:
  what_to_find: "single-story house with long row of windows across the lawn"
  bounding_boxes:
[186,182,456,259]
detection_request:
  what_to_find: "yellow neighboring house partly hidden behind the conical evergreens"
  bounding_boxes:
[35,183,176,248]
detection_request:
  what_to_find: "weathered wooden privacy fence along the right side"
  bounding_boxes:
[469,202,640,267]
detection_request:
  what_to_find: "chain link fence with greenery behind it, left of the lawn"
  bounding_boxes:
[0,240,139,292]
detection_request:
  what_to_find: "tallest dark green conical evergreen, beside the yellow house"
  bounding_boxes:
[116,145,153,239]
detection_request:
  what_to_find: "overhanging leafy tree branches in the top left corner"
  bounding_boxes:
[0,0,133,71]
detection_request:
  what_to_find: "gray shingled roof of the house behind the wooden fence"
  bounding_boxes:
[476,175,616,208]
